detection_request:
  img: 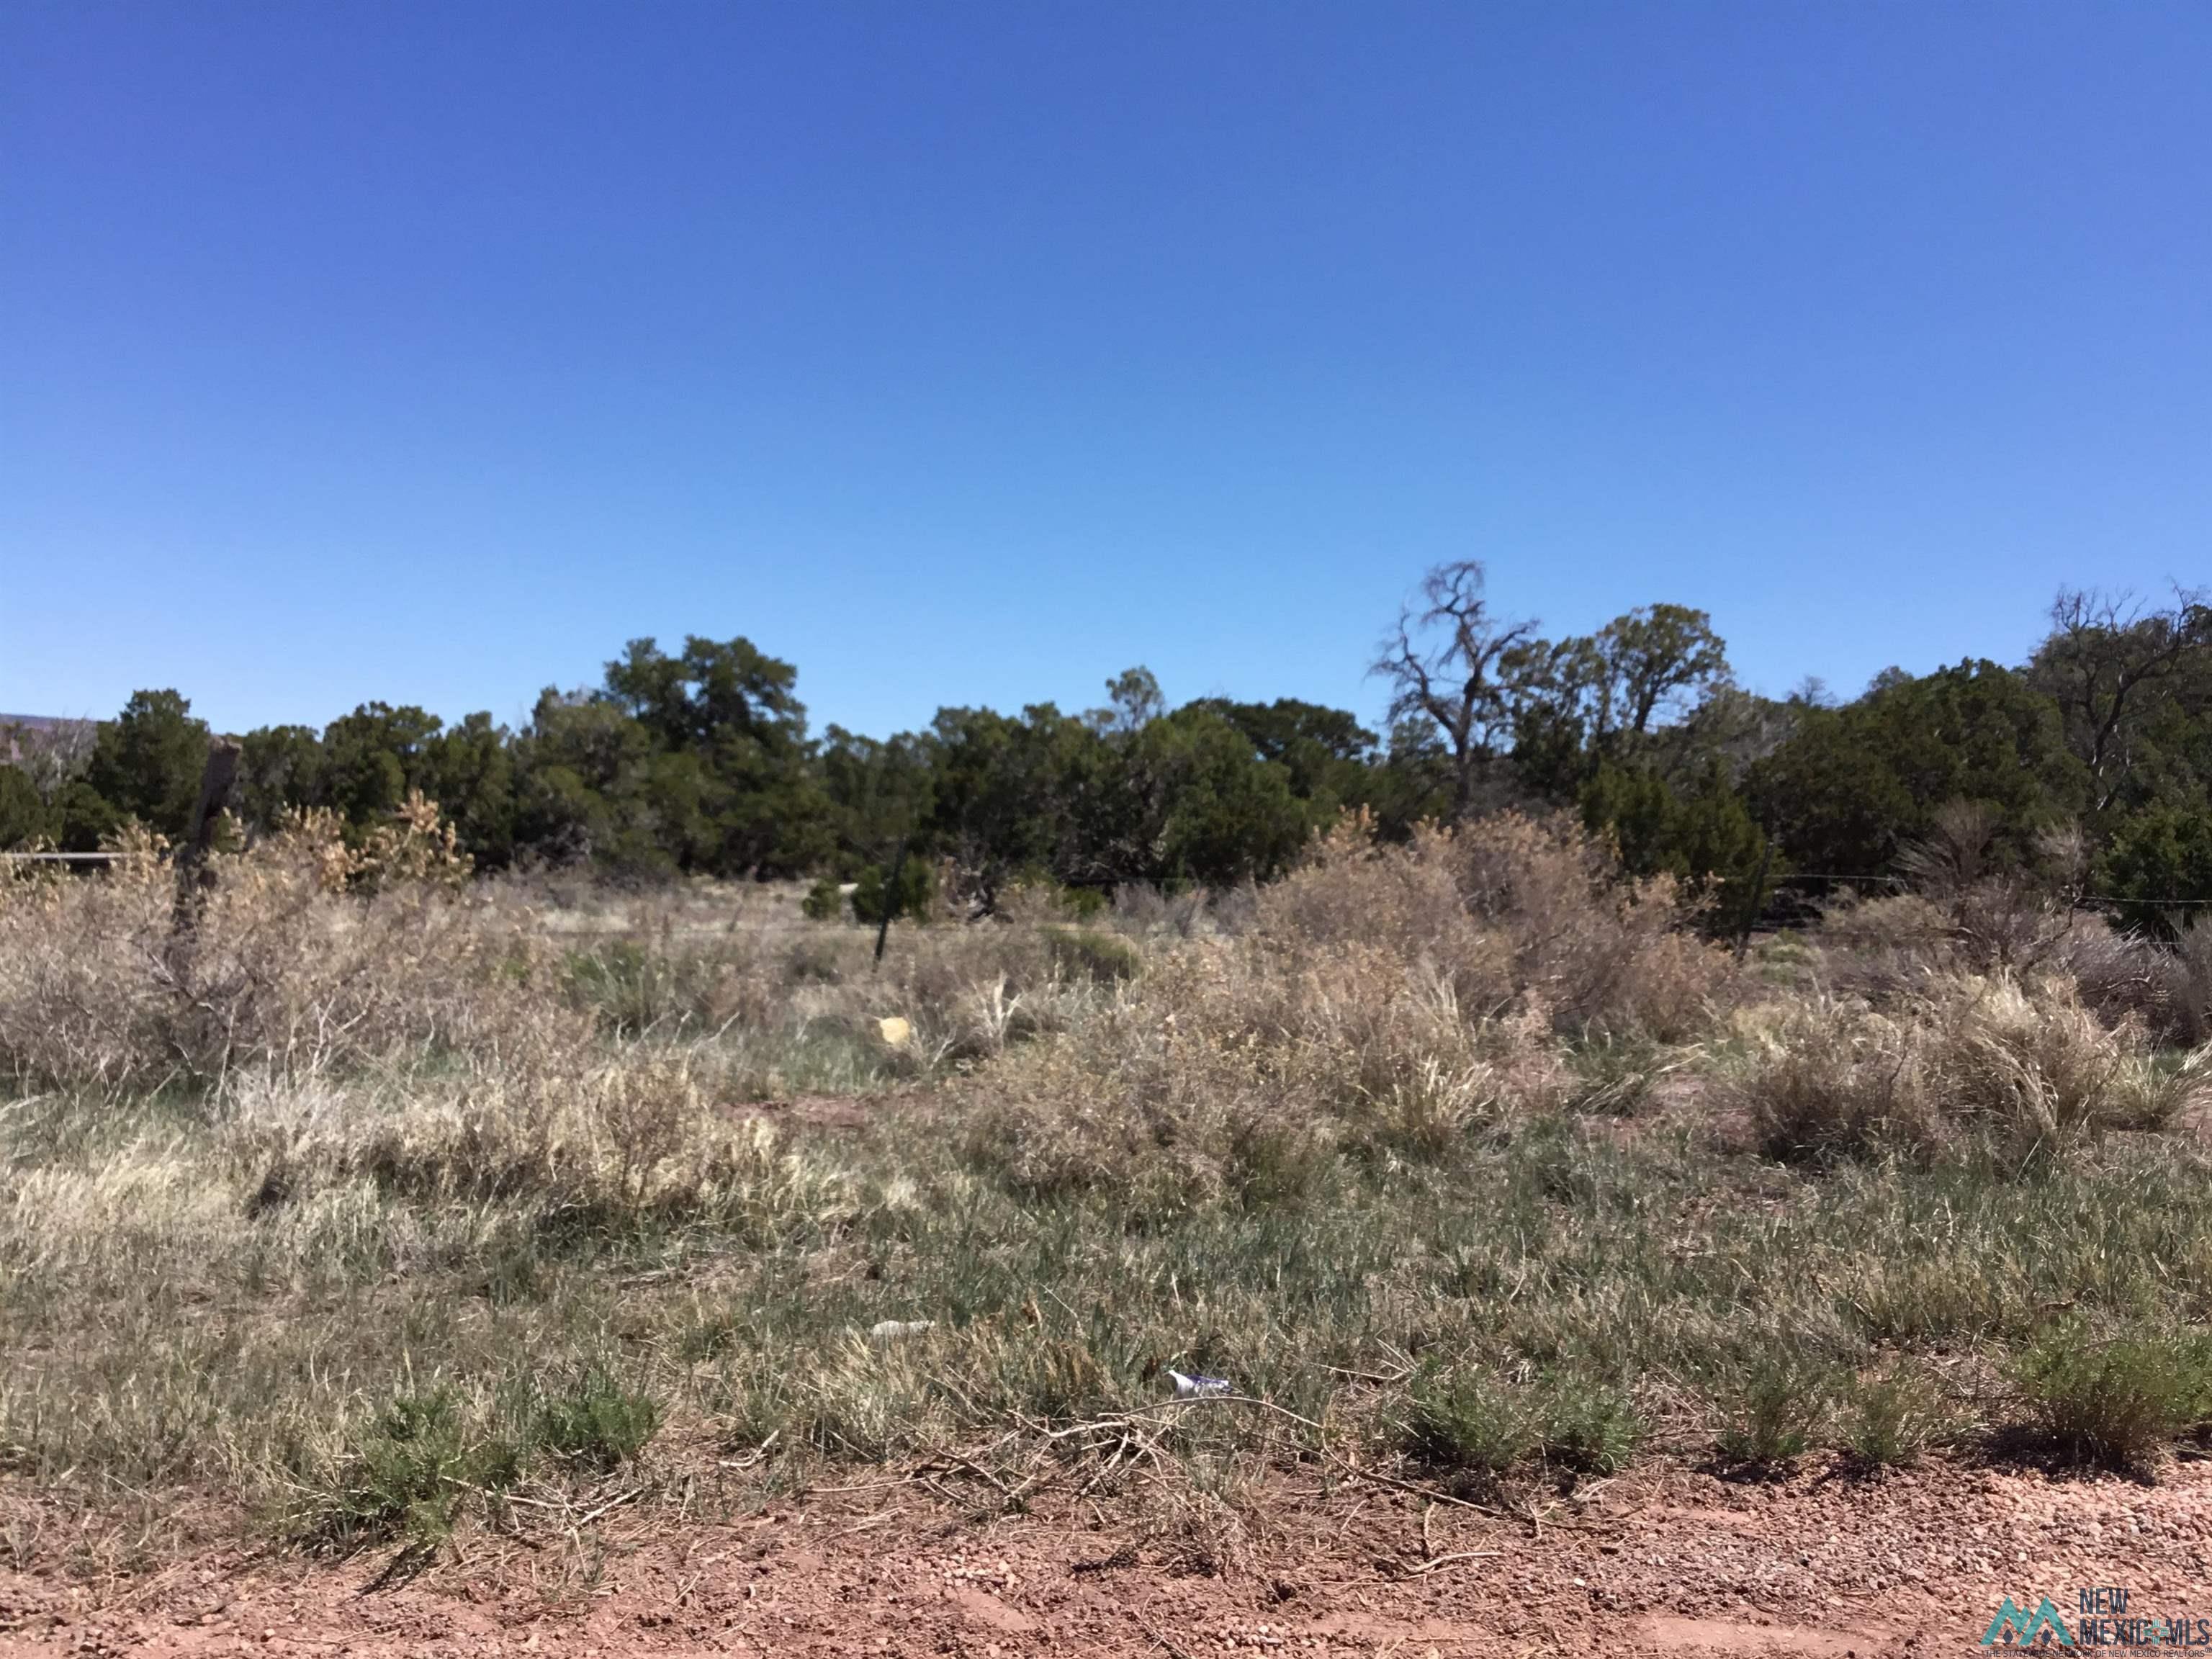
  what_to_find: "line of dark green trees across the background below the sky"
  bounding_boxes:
[0,562,2212,927]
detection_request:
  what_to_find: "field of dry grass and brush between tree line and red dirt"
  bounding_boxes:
[0,819,2212,1564]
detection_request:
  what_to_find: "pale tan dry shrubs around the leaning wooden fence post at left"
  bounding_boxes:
[0,801,573,1095]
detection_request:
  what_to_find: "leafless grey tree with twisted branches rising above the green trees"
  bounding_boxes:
[1370,559,1542,819]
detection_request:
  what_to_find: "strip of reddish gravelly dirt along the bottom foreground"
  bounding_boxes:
[0,1462,2212,1659]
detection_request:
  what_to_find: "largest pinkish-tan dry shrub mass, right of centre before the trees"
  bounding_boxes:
[971,819,1727,1203]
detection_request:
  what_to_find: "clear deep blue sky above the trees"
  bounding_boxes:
[0,0,2212,732]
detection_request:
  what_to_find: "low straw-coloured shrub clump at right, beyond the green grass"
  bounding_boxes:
[1723,976,2203,1157]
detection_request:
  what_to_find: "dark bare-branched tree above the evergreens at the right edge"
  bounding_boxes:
[2031,588,2212,811]
